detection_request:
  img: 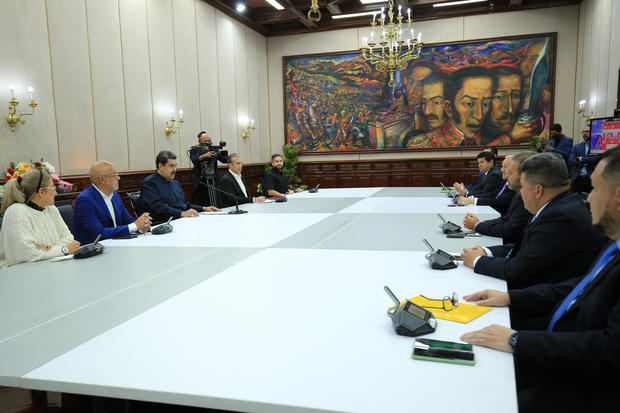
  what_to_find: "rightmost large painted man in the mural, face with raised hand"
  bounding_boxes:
[483,66,534,145]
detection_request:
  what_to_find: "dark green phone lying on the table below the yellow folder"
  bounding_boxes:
[411,338,476,366]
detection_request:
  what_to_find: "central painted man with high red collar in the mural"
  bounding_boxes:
[413,67,494,148]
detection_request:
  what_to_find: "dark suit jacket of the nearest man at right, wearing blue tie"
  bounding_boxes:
[510,240,620,412]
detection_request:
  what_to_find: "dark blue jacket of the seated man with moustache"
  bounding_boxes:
[140,172,202,223]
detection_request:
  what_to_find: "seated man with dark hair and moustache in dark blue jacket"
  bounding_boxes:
[140,151,219,222]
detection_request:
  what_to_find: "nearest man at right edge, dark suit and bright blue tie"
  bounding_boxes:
[461,148,620,413]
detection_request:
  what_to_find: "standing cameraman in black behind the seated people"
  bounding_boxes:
[189,131,220,206]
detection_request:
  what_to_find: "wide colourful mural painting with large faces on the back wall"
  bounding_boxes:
[283,33,556,153]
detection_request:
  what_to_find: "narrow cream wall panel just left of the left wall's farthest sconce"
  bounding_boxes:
[215,12,237,152]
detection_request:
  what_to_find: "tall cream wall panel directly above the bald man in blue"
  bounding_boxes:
[86,0,129,171]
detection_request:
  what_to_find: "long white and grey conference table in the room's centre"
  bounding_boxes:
[0,188,517,412]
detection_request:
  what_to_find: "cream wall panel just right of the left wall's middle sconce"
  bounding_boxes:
[173,0,200,167]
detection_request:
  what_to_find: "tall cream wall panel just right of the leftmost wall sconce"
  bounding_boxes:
[47,0,97,174]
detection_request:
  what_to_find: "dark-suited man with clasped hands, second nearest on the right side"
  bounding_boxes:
[461,153,607,288]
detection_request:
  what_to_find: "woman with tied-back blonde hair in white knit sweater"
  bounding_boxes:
[0,170,80,268]
